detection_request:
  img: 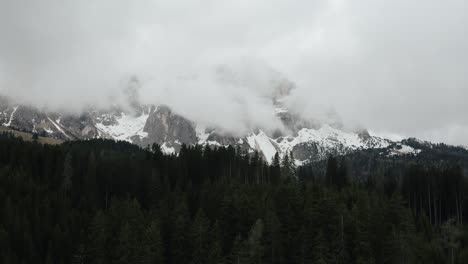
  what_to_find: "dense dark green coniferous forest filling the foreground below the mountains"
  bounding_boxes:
[0,134,468,264]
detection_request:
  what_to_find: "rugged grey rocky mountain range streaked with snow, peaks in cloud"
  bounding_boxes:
[0,73,438,165]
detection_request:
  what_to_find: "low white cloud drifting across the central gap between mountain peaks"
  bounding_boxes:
[141,59,284,135]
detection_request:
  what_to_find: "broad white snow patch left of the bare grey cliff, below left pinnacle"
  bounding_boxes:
[96,112,149,142]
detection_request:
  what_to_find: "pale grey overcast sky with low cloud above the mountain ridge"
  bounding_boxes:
[0,0,468,145]
